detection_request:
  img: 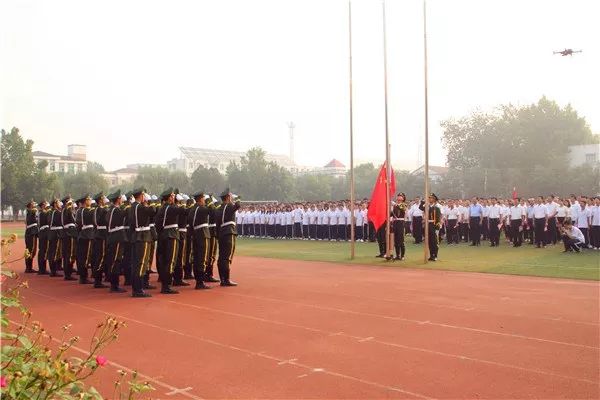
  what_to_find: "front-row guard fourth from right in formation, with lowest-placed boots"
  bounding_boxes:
[127,187,156,297]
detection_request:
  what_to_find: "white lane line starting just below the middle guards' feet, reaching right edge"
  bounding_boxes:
[168,300,597,384]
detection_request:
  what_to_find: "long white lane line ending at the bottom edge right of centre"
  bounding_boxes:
[30,290,433,399]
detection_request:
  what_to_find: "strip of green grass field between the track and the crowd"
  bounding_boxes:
[1,224,600,280]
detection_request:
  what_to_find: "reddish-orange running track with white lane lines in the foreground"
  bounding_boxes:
[5,257,600,399]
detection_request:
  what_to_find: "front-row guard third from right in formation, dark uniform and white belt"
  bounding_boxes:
[155,188,186,294]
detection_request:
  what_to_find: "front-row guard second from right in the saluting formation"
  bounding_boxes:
[188,192,211,289]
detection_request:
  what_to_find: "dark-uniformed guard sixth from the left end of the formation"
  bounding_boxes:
[91,192,109,289]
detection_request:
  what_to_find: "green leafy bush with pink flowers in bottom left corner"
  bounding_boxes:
[0,235,153,400]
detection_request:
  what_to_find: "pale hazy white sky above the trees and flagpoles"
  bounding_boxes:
[0,0,600,170]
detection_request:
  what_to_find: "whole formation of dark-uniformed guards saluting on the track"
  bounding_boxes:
[25,187,240,297]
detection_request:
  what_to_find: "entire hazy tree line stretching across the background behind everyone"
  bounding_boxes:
[1,97,600,217]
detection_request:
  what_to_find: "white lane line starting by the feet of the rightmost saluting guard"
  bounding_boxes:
[220,292,600,350]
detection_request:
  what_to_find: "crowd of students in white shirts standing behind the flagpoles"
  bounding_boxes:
[236,195,600,250]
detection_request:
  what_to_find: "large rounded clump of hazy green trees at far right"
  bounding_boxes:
[441,97,599,197]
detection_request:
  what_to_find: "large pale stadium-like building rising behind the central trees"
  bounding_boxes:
[167,147,297,176]
